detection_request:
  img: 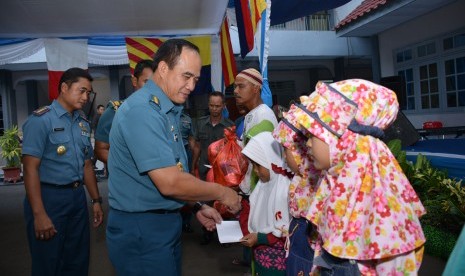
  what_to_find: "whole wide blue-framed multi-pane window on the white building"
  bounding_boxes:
[393,29,465,113]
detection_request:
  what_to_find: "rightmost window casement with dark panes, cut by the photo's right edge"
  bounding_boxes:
[444,56,465,107]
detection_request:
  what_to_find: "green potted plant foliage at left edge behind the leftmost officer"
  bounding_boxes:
[0,125,21,168]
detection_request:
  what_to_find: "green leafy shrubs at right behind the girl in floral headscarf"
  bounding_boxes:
[388,139,465,259]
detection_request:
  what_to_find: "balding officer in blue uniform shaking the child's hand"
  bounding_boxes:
[106,39,241,276]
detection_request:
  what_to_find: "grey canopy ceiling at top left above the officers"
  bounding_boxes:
[0,0,228,38]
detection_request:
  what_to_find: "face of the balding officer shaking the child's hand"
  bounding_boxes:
[159,48,202,104]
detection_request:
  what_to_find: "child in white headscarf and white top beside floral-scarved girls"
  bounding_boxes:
[241,132,292,275]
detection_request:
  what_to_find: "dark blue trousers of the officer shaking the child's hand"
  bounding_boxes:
[106,209,182,276]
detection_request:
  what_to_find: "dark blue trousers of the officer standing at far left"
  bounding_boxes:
[24,185,90,276]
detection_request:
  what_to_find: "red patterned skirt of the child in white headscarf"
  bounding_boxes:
[253,241,286,271]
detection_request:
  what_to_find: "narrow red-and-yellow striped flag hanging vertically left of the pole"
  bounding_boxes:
[220,16,237,86]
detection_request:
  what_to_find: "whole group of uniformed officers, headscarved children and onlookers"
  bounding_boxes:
[23,39,458,275]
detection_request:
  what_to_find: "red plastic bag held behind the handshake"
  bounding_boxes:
[208,126,249,187]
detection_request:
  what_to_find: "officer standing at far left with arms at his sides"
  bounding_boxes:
[22,68,103,276]
